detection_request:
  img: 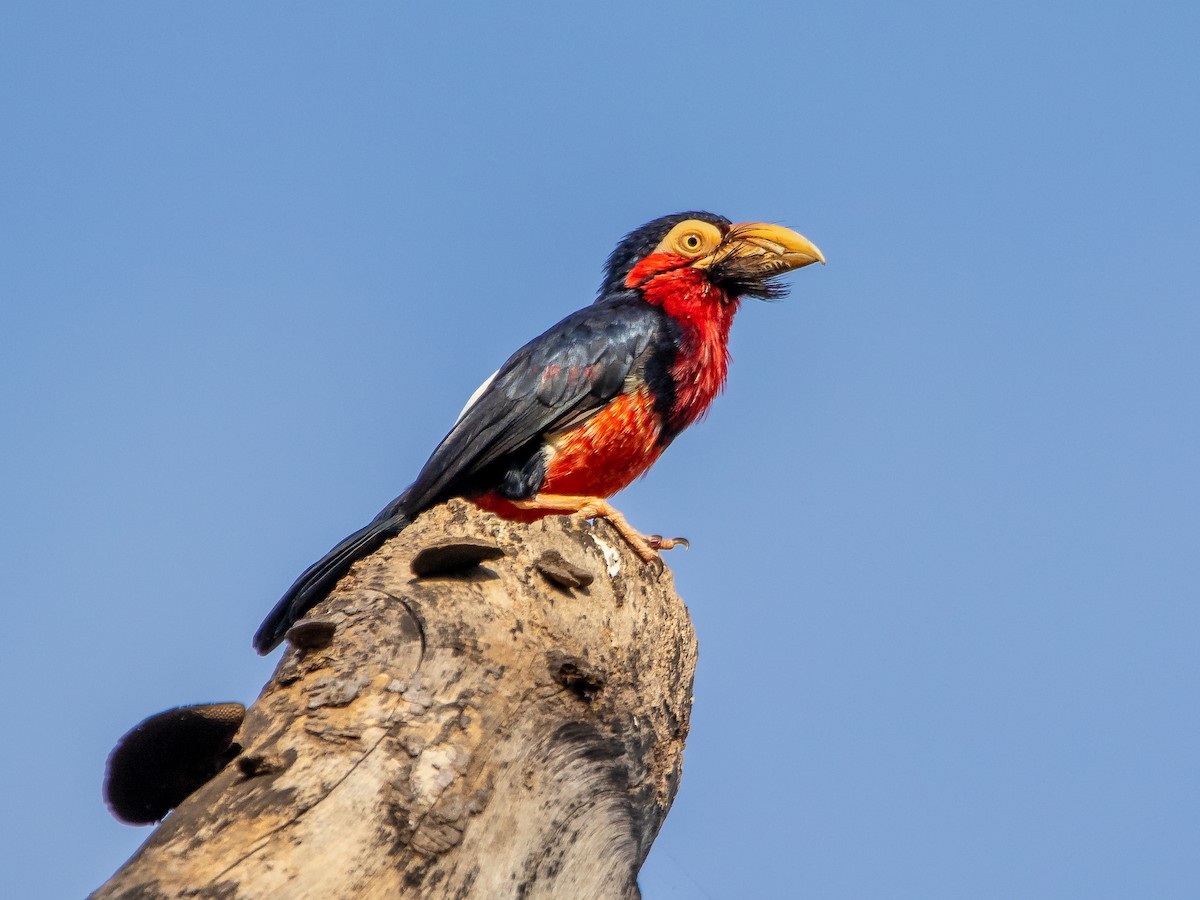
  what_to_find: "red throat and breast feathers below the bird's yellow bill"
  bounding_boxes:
[625,253,739,431]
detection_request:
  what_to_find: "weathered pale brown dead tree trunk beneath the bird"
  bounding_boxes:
[94,502,696,900]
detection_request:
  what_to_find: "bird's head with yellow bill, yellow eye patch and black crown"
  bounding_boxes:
[601,212,824,302]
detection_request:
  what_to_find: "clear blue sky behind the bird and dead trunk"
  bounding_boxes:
[0,1,1200,900]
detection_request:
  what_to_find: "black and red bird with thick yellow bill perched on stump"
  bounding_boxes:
[254,211,826,654]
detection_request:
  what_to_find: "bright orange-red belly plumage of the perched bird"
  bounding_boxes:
[472,386,664,521]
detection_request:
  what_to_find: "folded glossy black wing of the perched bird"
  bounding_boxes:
[396,298,678,516]
